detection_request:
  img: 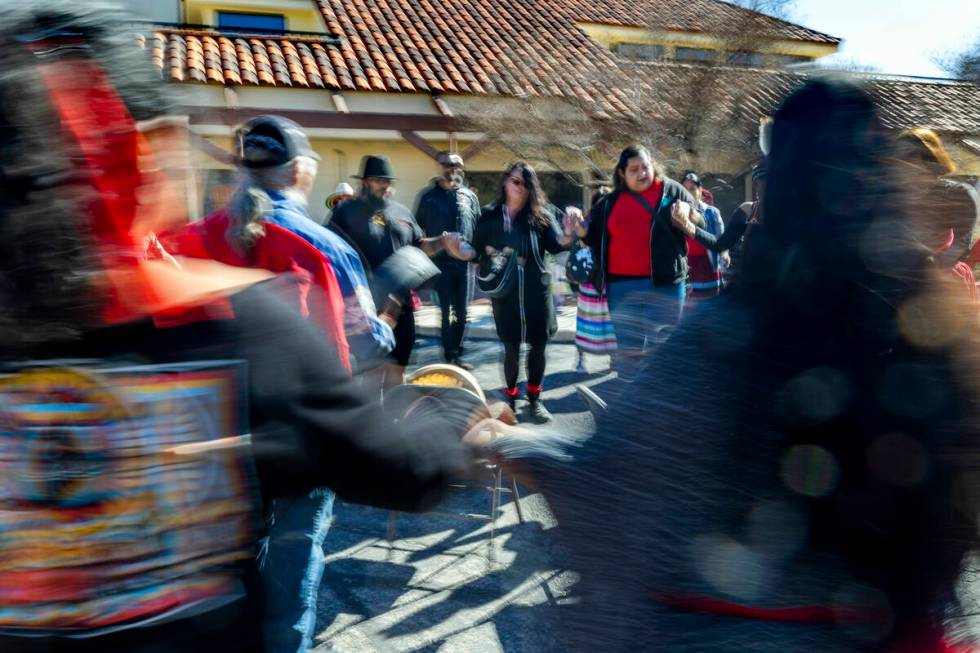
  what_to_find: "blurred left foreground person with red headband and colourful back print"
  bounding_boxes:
[0,1,520,652]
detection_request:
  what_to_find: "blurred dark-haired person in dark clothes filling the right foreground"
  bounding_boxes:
[535,79,980,653]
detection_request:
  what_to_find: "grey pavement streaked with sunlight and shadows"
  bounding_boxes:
[317,338,610,653]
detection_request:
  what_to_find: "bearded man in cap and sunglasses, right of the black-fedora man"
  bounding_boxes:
[415,152,480,369]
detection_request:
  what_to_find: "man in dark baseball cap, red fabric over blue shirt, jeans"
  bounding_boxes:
[160,115,383,651]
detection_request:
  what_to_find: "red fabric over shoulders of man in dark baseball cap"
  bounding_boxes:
[160,210,350,371]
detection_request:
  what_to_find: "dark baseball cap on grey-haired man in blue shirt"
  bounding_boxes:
[236,115,320,168]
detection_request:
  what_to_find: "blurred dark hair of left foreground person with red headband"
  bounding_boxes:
[0,1,169,351]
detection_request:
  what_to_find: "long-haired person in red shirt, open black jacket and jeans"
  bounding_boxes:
[579,145,704,371]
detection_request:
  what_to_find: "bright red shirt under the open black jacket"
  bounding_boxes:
[609,179,664,277]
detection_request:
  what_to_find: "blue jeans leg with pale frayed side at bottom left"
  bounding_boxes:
[259,488,335,653]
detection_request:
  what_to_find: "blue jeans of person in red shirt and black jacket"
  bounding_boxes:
[606,279,686,357]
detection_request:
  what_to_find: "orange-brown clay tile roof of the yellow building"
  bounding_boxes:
[140,0,980,133]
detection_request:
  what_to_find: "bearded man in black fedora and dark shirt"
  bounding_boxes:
[330,155,445,389]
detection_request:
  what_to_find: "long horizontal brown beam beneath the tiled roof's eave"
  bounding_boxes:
[183,107,460,132]
